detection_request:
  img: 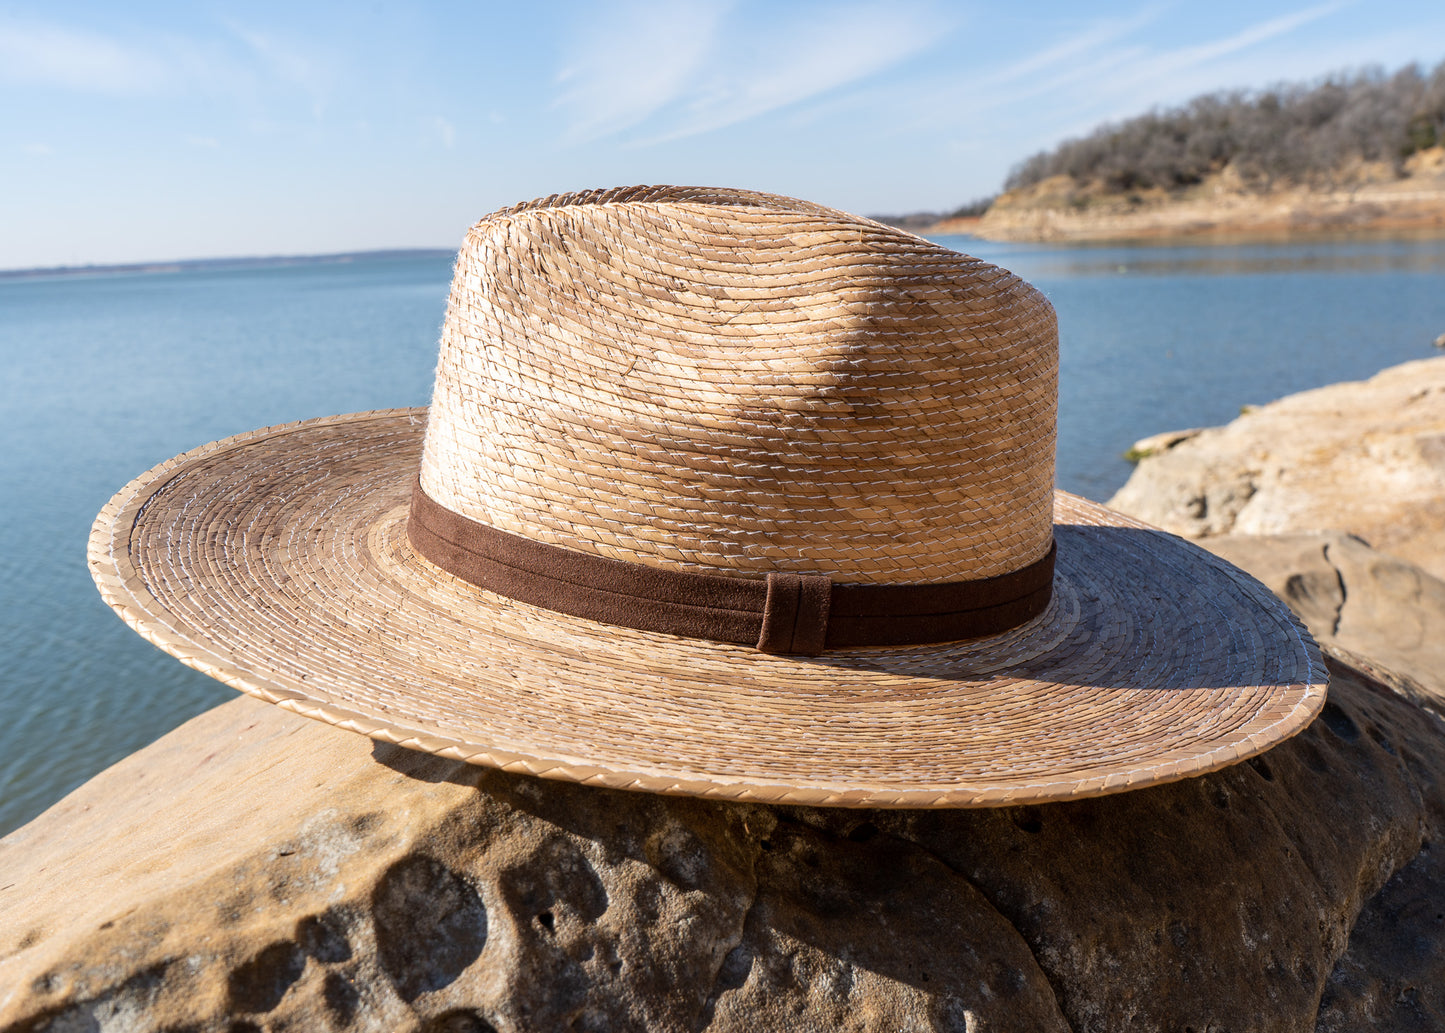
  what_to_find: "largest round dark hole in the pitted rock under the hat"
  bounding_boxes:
[371,854,487,1003]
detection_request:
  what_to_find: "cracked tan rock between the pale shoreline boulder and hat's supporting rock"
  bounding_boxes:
[1201,535,1445,715]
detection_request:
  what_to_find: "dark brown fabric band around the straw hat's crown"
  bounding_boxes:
[406,478,1058,656]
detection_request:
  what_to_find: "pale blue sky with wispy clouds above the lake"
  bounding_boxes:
[0,0,1445,269]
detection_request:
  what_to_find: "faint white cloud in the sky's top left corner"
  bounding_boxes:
[0,20,169,94]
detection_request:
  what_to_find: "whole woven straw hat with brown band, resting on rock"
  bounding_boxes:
[90,186,1325,808]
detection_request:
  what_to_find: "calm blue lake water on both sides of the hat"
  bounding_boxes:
[0,237,1445,834]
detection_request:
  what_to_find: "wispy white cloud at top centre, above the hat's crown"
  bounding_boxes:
[556,0,945,143]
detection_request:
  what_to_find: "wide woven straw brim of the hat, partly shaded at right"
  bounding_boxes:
[90,409,1327,808]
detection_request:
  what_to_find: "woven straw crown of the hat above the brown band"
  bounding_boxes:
[420,188,1058,584]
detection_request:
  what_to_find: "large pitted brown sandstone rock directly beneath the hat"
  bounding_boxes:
[0,650,1445,1033]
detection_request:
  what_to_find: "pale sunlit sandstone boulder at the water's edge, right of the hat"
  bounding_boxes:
[1108,358,1445,578]
